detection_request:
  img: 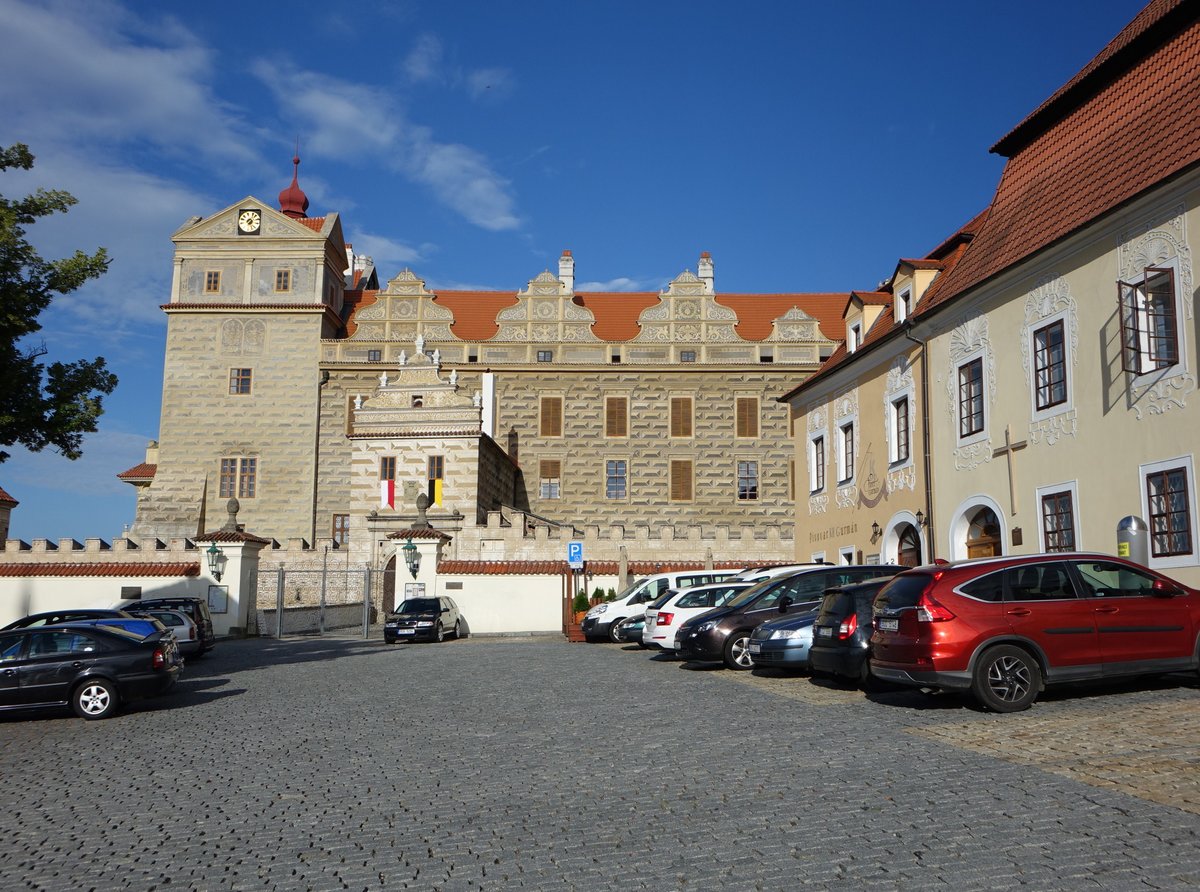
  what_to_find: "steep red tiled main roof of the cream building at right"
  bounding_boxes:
[922,0,1200,307]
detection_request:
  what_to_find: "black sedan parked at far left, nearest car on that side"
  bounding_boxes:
[0,624,181,719]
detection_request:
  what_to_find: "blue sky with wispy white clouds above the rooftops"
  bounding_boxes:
[0,0,1142,540]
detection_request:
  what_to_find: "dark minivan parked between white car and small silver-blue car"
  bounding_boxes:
[676,564,897,669]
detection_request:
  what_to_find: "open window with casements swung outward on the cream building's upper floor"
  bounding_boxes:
[1117,267,1180,375]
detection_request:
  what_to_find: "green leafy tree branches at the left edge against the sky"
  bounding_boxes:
[0,143,116,462]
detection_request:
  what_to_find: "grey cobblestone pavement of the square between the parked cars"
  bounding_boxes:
[0,637,1200,891]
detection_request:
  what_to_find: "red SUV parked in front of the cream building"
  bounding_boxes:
[871,553,1200,712]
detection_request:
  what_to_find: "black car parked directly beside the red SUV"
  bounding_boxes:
[806,574,893,690]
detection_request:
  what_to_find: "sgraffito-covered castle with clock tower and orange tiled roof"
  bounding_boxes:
[120,158,848,565]
